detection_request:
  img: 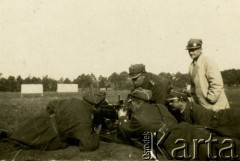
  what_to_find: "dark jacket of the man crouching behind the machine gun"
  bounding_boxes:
[140,73,172,104]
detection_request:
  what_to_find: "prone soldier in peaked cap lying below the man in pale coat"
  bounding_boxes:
[167,91,240,138]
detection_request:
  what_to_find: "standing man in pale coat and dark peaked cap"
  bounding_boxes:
[186,39,229,111]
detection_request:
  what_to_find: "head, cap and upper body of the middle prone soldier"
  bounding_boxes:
[118,89,177,143]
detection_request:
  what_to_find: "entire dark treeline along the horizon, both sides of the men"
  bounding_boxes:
[0,69,240,92]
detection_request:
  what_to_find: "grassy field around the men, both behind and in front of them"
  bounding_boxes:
[0,88,240,160]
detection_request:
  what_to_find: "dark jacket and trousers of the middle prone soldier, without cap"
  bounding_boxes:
[119,104,217,160]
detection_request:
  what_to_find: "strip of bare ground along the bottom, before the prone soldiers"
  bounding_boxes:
[0,141,143,160]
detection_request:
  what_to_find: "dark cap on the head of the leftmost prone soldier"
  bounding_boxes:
[83,91,106,105]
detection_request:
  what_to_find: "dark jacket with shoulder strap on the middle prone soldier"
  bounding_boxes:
[119,103,177,141]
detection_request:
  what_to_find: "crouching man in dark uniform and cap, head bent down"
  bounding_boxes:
[129,64,172,104]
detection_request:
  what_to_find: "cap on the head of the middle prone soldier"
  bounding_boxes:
[130,88,152,101]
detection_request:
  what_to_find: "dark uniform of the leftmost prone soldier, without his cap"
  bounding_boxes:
[10,98,99,150]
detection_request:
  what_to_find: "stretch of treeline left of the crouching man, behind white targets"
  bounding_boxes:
[0,72,132,92]
